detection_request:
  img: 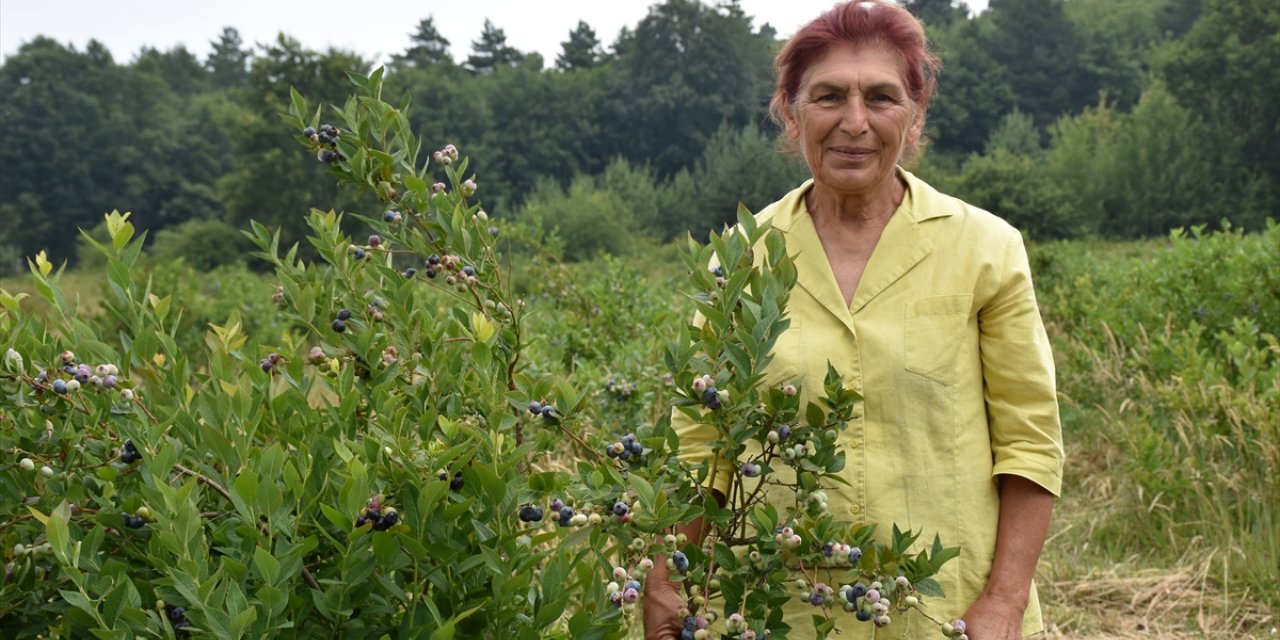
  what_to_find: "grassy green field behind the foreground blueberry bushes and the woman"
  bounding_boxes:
[0,218,1280,639]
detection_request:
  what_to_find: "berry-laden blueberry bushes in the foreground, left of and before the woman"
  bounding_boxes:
[0,70,964,640]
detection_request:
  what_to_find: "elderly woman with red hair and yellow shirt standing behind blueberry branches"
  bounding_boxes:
[645,1,1062,640]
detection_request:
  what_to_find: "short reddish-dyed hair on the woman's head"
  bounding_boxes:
[769,0,941,124]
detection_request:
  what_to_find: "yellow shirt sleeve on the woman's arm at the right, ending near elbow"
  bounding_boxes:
[978,229,1065,495]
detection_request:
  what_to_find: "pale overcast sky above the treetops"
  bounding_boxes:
[0,0,987,67]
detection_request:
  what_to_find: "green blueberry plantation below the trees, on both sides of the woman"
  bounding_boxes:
[0,73,1280,640]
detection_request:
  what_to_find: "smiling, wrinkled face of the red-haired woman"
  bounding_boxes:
[786,44,923,197]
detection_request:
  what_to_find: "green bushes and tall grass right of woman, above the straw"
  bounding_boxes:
[1033,223,1280,611]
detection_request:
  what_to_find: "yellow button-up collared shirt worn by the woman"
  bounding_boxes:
[673,172,1064,640]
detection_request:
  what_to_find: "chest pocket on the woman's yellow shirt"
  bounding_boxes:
[902,293,973,384]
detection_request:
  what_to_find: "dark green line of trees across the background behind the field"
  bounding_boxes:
[0,0,1280,274]
